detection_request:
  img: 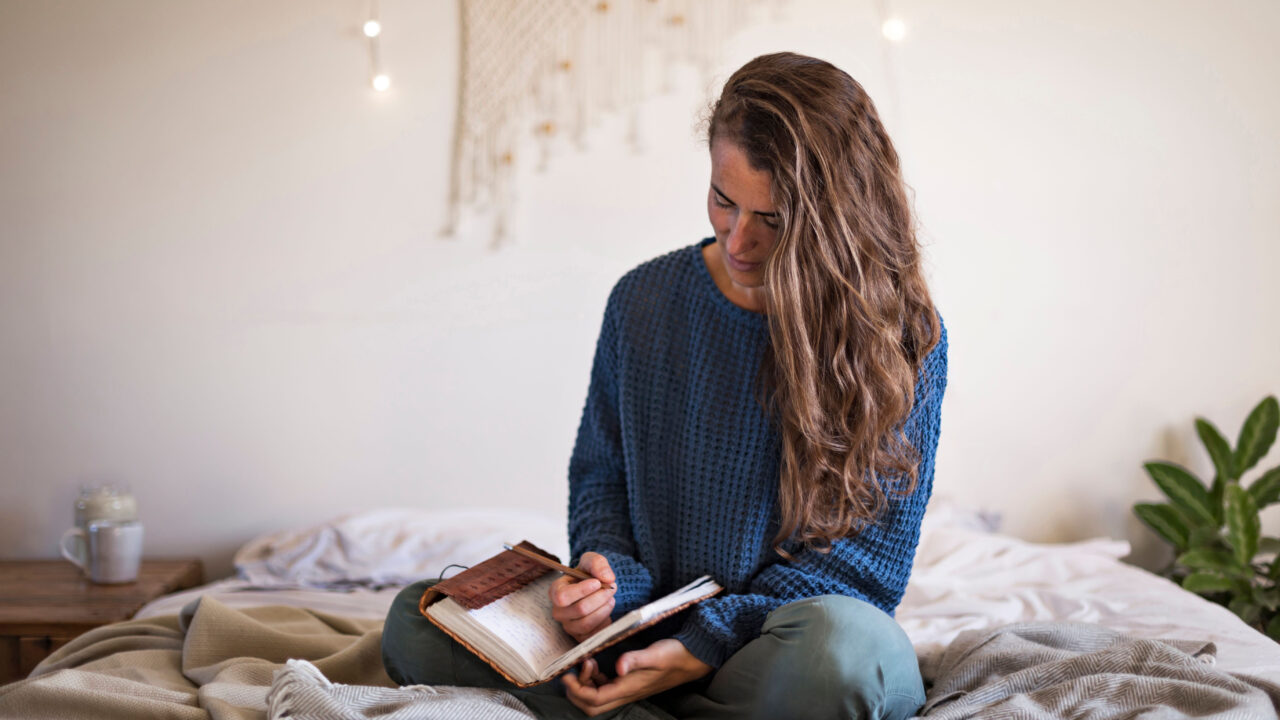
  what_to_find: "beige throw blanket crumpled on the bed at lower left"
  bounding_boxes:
[0,597,394,720]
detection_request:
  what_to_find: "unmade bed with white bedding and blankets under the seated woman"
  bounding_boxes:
[0,497,1280,720]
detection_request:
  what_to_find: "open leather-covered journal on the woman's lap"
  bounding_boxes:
[420,542,721,688]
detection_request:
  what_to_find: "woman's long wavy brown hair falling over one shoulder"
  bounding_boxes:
[707,53,941,557]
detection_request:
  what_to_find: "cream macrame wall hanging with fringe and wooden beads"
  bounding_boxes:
[444,0,786,245]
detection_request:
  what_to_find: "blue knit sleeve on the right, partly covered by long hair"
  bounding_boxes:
[676,322,947,667]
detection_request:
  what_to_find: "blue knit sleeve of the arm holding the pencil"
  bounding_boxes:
[568,288,653,609]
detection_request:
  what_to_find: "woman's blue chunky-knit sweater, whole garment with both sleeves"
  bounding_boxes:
[568,238,947,667]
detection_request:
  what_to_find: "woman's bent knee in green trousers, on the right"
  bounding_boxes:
[763,596,924,719]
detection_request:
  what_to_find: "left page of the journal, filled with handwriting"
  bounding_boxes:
[467,573,575,671]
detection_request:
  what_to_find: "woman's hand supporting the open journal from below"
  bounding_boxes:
[564,638,712,717]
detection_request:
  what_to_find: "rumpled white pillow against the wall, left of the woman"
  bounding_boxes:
[236,507,568,588]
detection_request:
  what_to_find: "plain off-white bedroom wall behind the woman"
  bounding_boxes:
[0,0,1280,577]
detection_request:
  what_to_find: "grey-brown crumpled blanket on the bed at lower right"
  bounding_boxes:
[920,623,1280,720]
